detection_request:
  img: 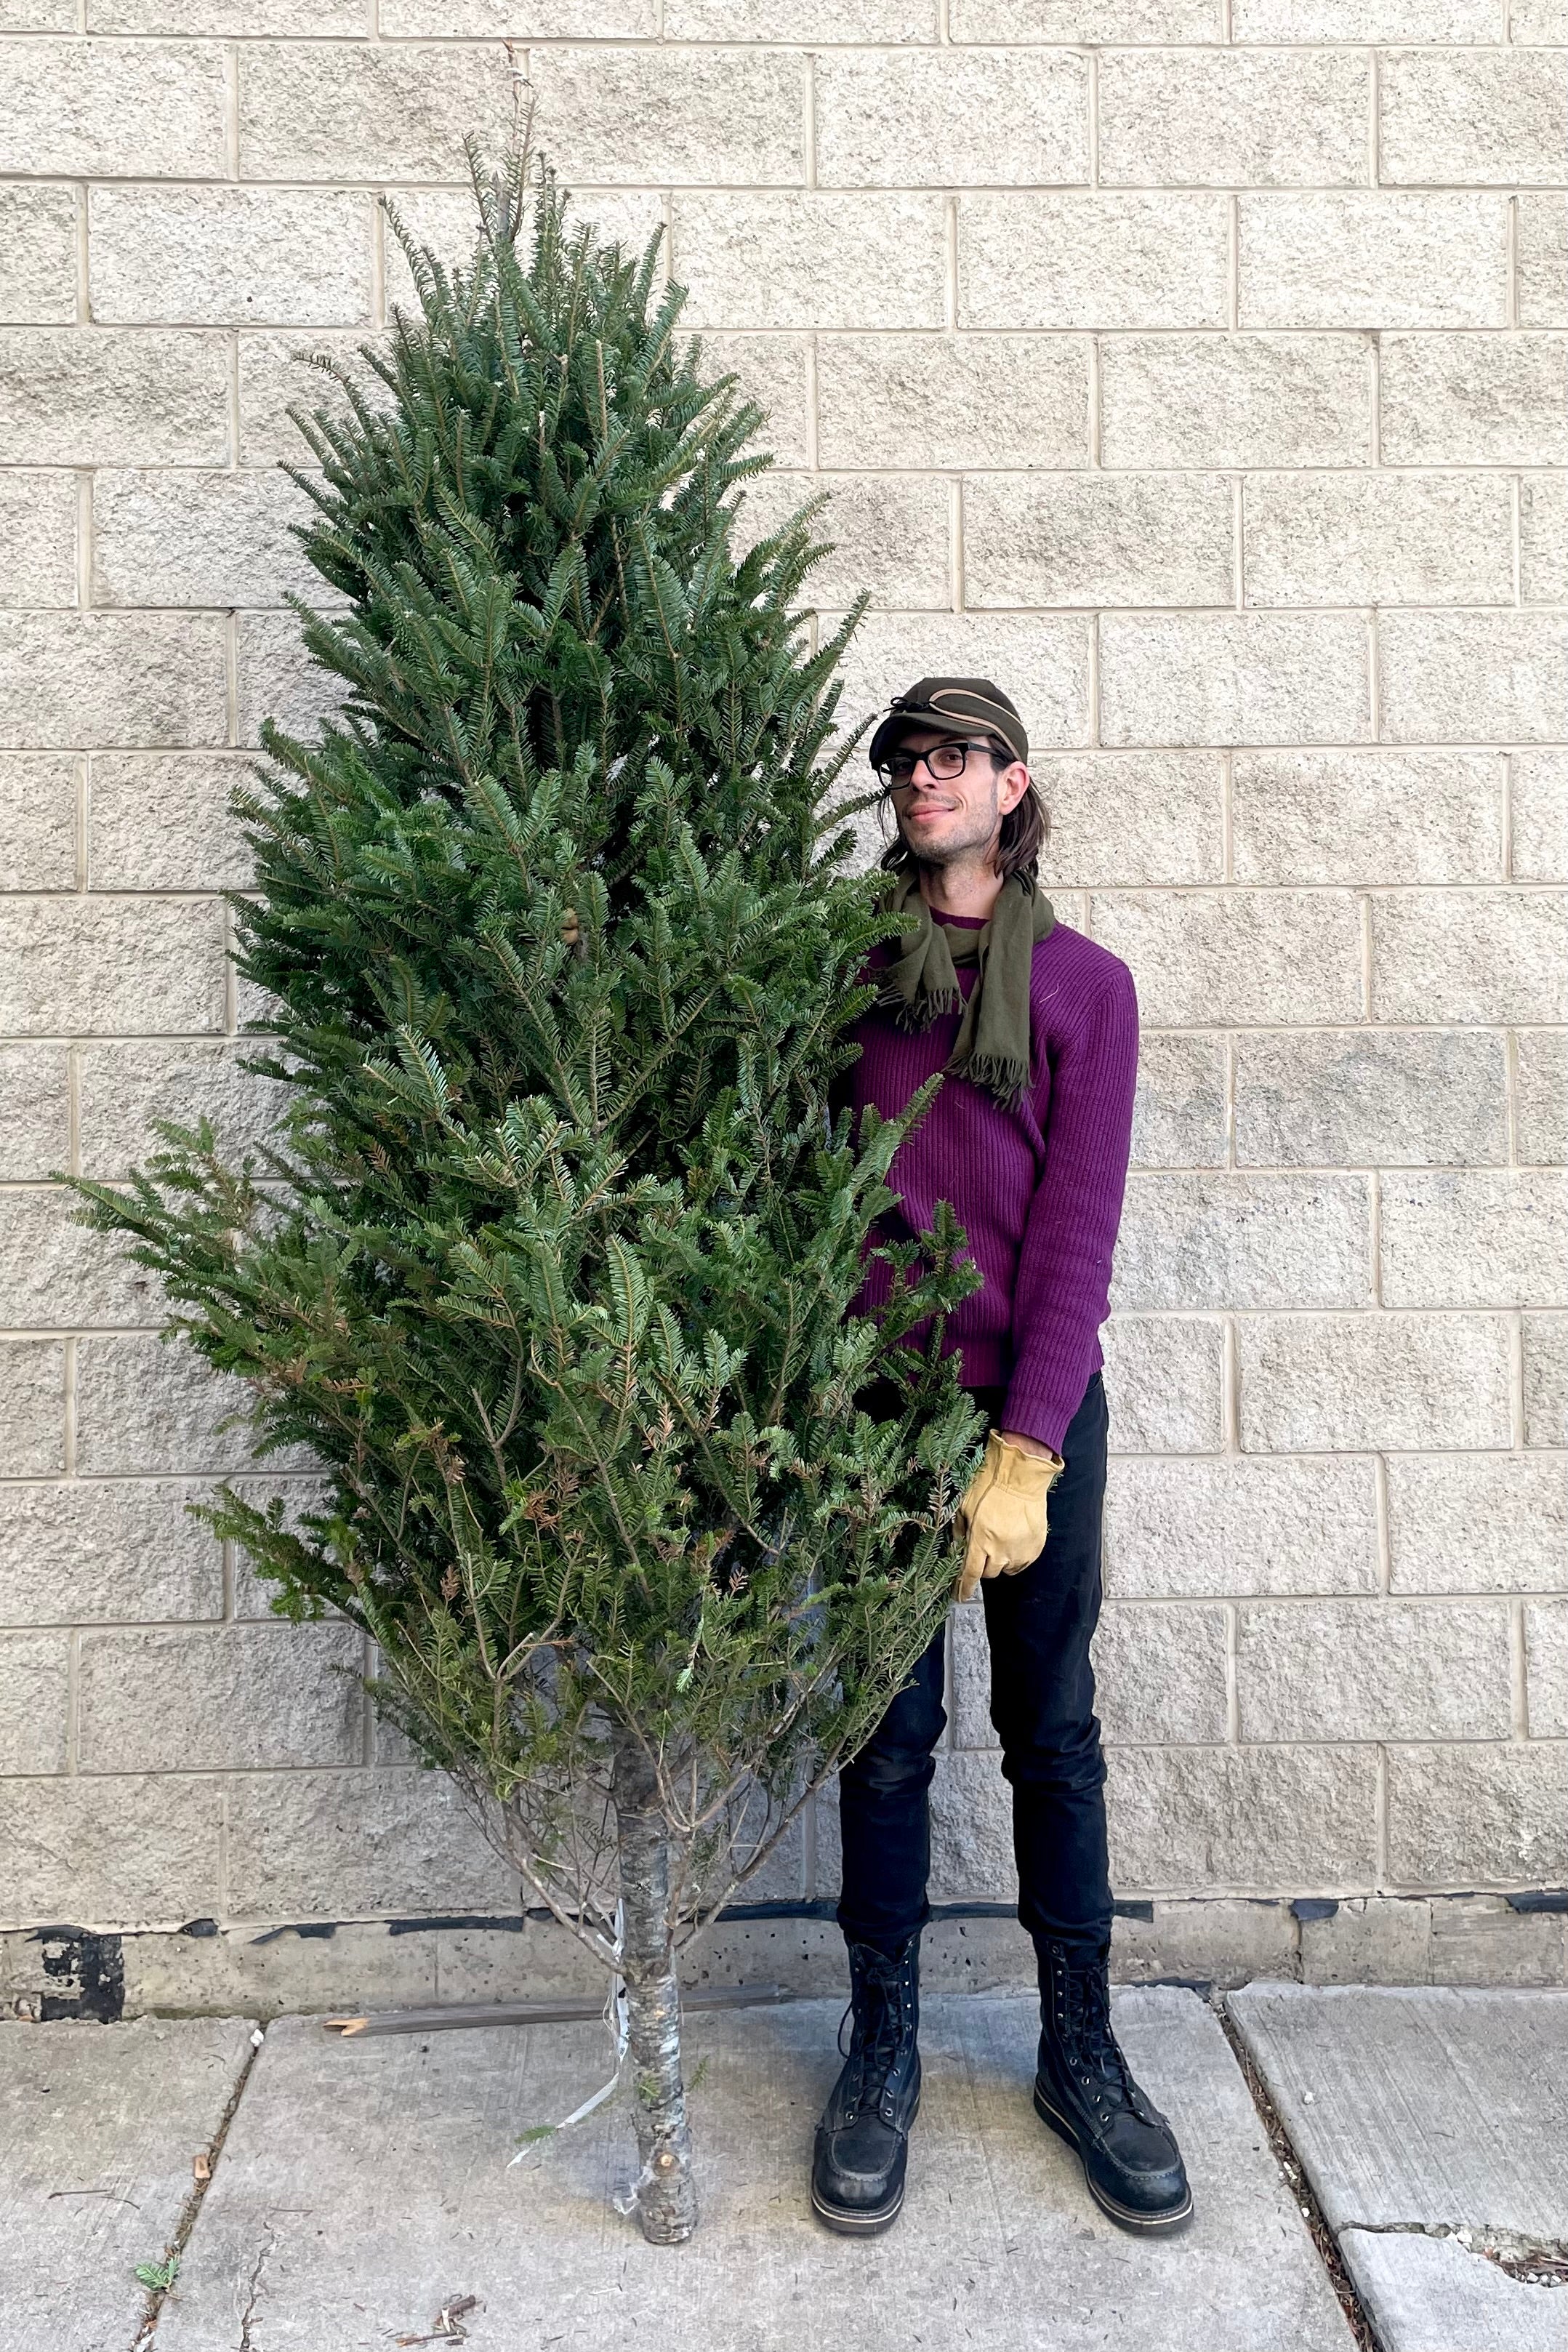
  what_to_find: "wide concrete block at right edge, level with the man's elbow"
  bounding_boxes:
[1383,1169,1568,1308]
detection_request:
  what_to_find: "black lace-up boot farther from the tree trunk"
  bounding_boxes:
[1034,1938,1192,2232]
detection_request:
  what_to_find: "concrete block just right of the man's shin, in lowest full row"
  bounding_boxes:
[1107,1745,1378,1895]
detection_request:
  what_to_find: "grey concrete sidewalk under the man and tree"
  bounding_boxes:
[0,1985,1568,2352]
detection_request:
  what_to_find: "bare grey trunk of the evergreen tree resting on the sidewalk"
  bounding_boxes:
[614,1731,696,2246]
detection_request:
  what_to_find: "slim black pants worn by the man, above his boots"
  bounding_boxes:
[839,1373,1112,1957]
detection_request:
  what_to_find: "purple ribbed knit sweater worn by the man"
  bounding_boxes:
[846,915,1138,1453]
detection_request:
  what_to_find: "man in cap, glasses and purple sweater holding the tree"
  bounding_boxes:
[811,678,1192,2234]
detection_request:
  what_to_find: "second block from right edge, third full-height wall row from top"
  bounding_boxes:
[1100,334,1373,466]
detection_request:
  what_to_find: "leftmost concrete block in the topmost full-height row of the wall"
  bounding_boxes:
[0,40,225,179]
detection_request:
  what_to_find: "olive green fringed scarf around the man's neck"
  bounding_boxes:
[882,875,1056,1110]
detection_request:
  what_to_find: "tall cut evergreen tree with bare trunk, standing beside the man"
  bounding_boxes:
[82,147,981,2241]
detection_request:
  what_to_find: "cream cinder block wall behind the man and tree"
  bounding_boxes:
[0,0,1568,1926]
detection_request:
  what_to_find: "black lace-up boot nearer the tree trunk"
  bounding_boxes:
[811,1935,919,2236]
